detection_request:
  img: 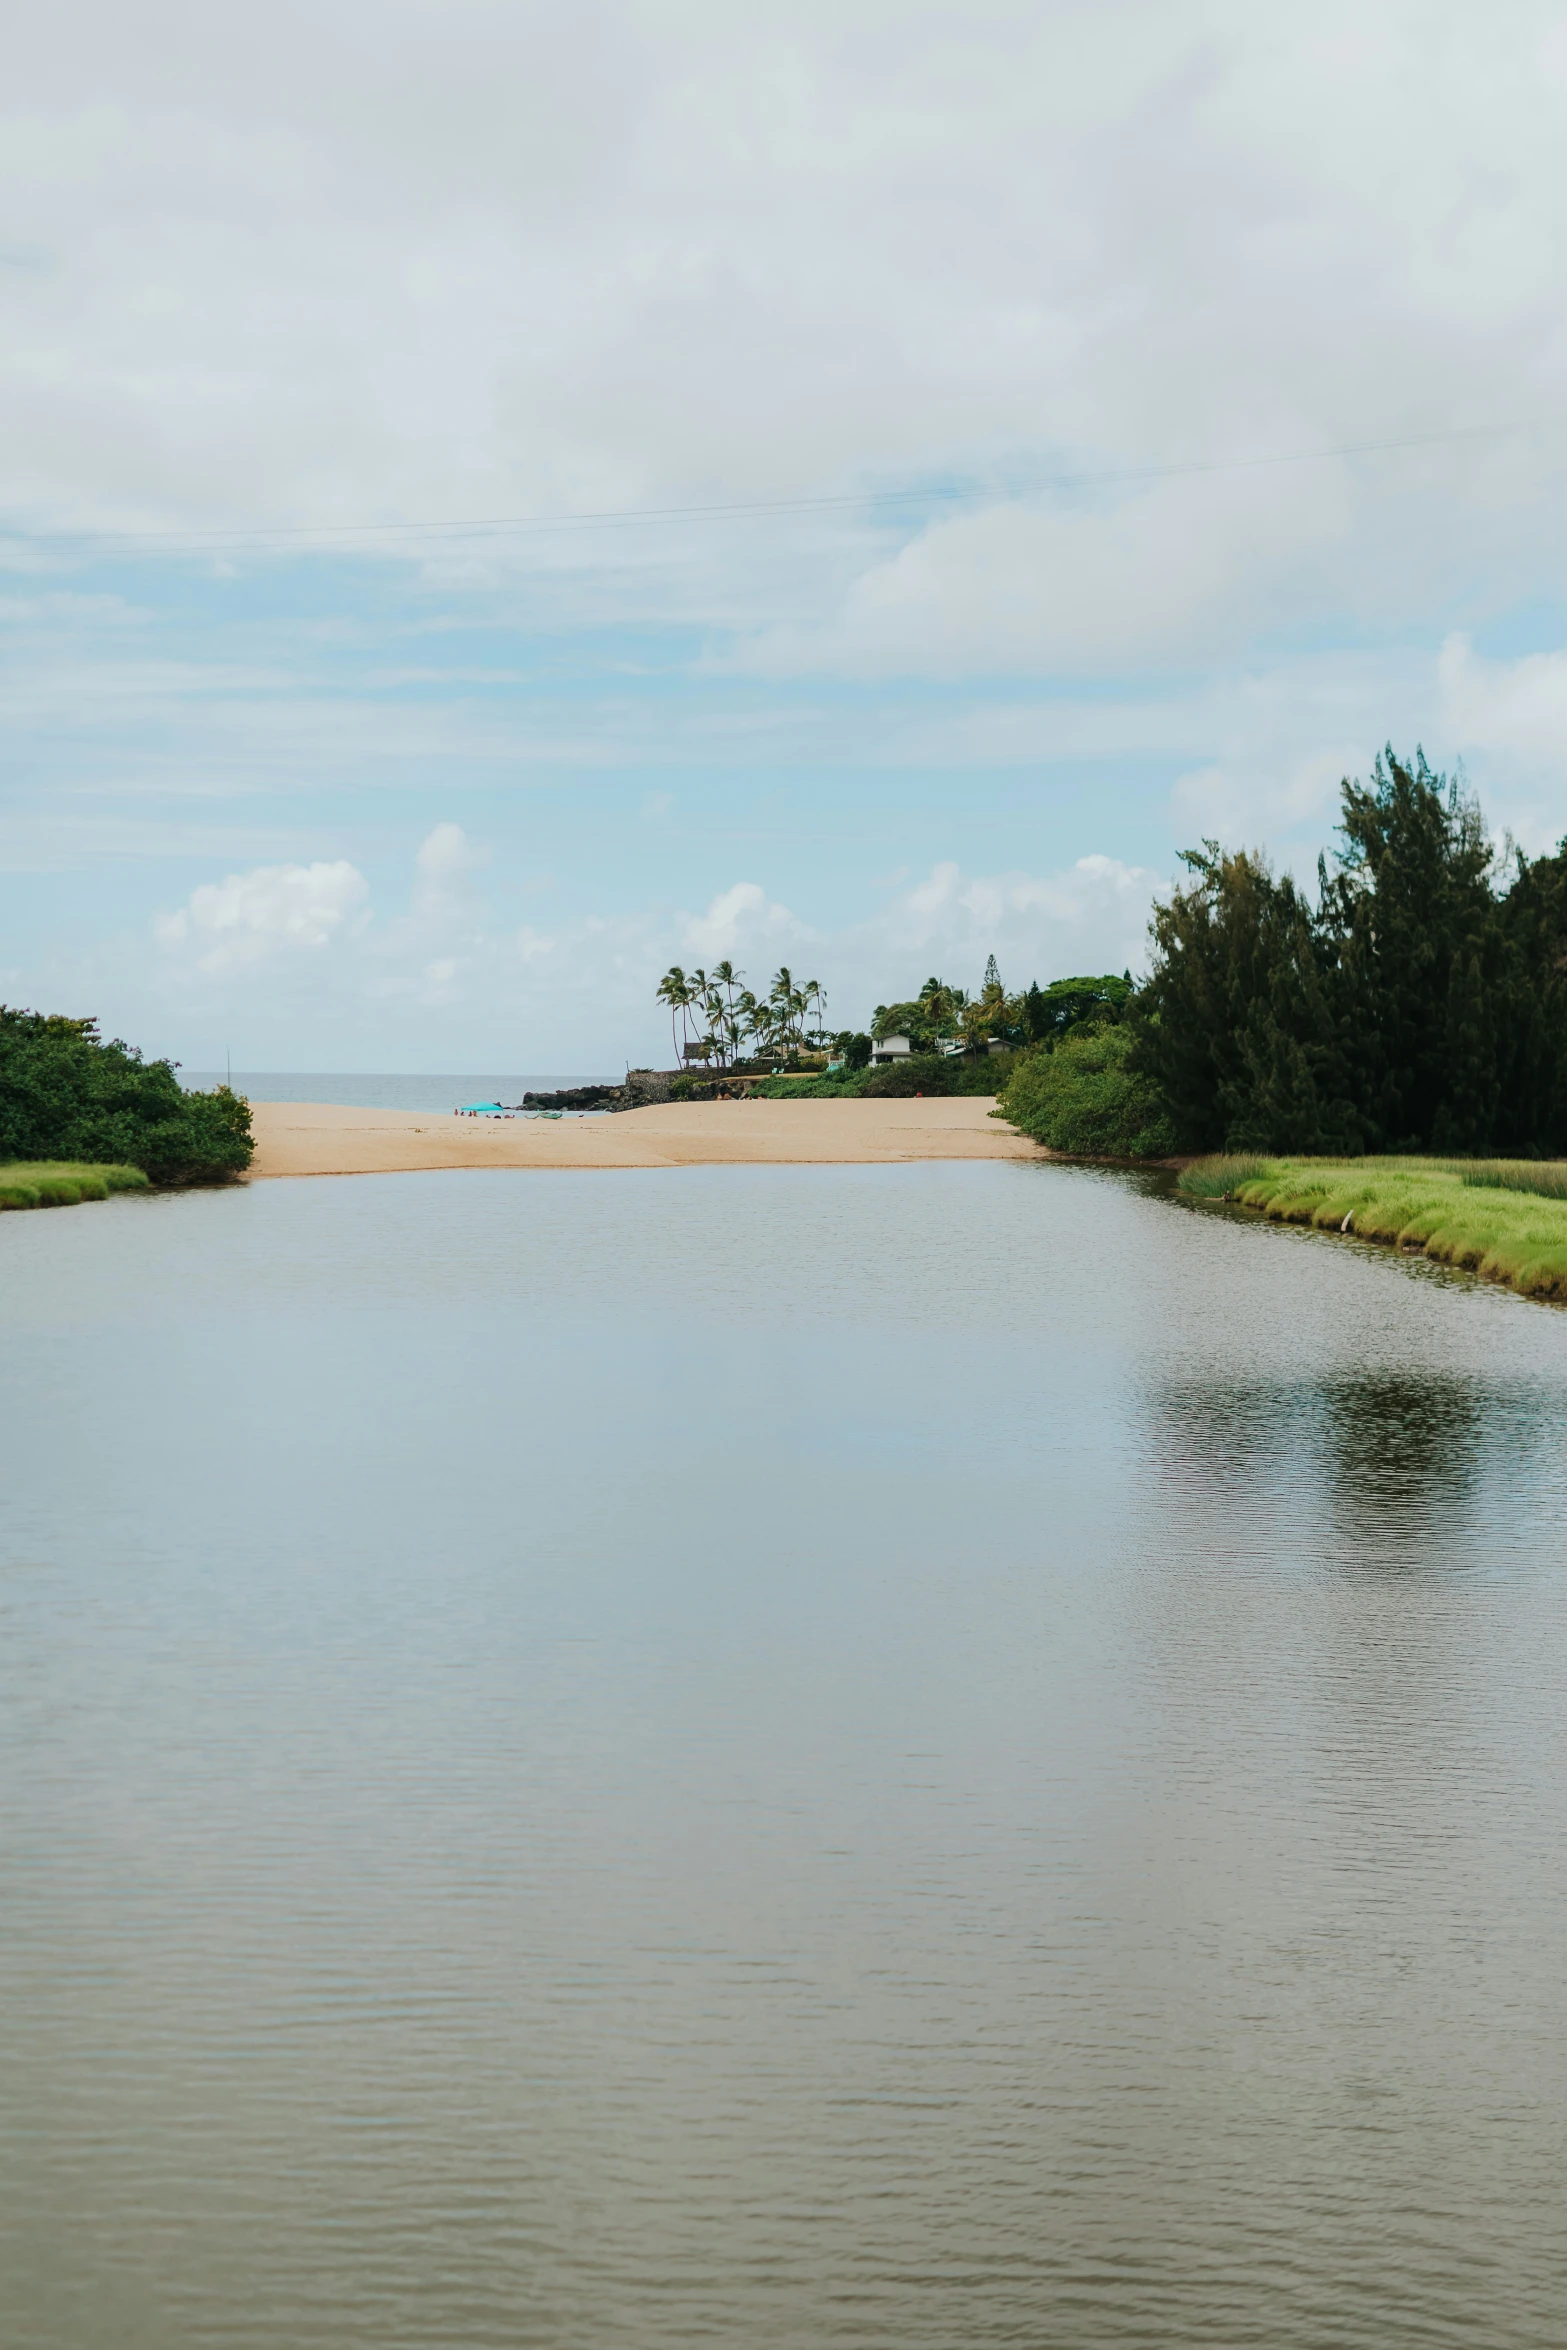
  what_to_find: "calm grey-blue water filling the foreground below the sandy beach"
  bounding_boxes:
[0,1163,1567,2350]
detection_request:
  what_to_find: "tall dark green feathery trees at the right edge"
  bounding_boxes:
[1130,750,1567,1156]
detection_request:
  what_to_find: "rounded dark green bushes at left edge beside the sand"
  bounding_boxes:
[0,1006,251,1182]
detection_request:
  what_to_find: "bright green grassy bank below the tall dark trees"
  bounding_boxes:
[1179,1156,1567,1302]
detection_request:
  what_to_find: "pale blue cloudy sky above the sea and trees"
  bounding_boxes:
[0,0,1567,1074]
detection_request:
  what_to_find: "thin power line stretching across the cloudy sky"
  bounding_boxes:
[0,418,1558,552]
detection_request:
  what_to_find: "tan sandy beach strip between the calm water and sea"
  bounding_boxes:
[251,1097,1041,1175]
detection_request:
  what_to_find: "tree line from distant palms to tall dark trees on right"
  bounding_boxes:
[660,747,1567,1159]
